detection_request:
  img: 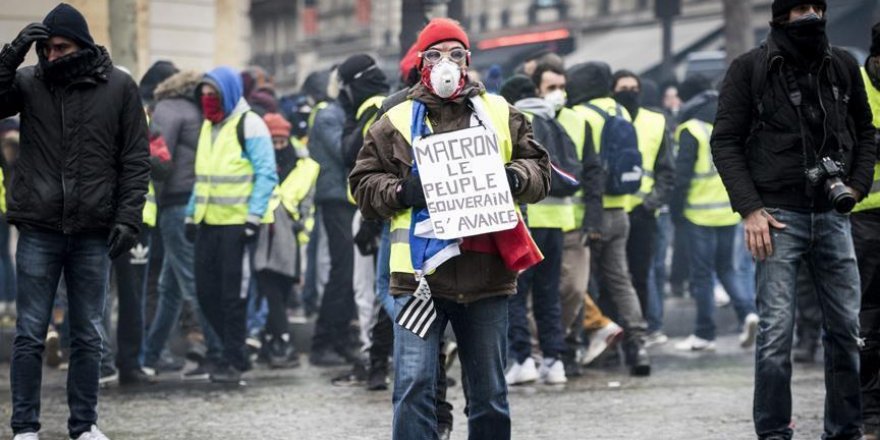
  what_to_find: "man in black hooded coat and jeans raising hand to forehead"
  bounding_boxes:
[0,3,150,440]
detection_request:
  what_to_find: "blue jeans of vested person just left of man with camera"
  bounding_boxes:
[687,222,755,341]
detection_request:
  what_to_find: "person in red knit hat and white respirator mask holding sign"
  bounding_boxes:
[349,18,550,440]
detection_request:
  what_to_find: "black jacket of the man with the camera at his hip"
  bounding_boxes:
[711,35,876,216]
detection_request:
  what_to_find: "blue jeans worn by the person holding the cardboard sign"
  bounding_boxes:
[392,295,510,440]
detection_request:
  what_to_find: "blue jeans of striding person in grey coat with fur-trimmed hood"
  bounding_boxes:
[143,205,223,367]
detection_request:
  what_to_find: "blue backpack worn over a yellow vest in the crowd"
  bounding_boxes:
[585,104,644,196]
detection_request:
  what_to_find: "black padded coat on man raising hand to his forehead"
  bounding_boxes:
[0,46,150,234]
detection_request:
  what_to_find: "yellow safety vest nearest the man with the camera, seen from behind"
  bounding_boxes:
[675,119,740,227]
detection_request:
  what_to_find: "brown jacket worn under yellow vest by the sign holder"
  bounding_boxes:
[349,83,550,303]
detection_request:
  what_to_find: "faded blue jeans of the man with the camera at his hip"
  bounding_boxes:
[754,209,862,440]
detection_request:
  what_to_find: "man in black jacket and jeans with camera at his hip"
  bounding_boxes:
[711,0,877,439]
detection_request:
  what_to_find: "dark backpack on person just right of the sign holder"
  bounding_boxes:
[532,117,583,197]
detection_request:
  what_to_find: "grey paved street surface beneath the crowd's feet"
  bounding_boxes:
[0,300,824,440]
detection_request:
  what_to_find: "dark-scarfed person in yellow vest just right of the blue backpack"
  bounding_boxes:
[611,70,675,345]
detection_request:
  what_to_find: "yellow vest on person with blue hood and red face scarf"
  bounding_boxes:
[193,112,275,225]
